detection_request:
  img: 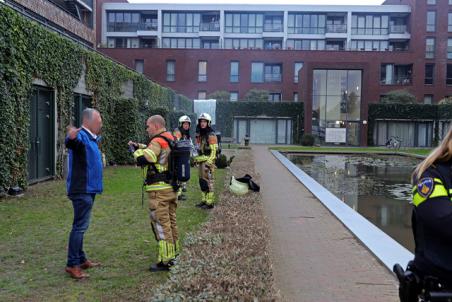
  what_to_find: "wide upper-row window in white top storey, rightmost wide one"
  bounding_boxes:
[352,14,389,35]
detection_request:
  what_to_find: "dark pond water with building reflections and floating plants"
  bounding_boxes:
[286,154,419,251]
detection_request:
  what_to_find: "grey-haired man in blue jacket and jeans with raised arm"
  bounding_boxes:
[65,108,103,279]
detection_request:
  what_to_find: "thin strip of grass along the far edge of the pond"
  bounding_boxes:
[270,146,432,156]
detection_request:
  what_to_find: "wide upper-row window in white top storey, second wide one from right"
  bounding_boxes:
[287,13,326,34]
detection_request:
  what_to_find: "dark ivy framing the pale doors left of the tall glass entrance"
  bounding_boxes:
[216,101,304,144]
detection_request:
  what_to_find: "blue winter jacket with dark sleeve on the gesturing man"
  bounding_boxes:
[65,128,103,195]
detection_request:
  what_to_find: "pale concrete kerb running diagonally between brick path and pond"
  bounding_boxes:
[271,150,414,271]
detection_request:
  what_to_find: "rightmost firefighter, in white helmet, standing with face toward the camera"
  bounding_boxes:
[194,113,218,209]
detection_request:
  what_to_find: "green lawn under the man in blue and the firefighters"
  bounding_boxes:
[0,167,225,301]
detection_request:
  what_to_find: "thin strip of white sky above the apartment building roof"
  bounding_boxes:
[128,0,384,5]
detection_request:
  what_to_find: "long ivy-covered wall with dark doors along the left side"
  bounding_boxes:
[0,5,193,188]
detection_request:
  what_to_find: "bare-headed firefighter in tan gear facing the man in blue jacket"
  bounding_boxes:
[129,115,180,272]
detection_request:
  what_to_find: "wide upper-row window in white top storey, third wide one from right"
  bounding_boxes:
[224,12,264,34]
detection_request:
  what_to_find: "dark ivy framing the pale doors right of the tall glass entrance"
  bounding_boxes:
[367,104,452,146]
